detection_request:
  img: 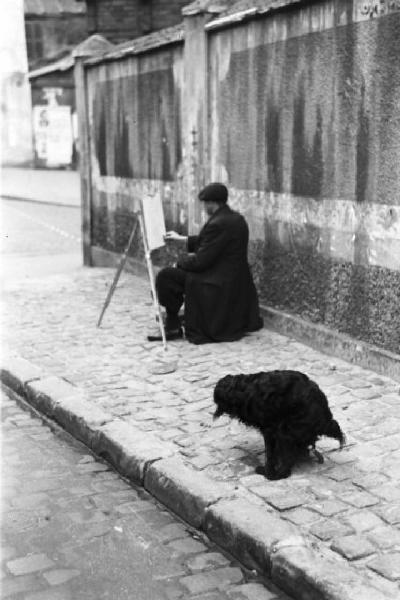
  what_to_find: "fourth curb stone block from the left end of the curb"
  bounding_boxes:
[92,419,176,485]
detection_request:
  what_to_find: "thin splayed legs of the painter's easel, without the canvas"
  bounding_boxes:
[97,205,167,351]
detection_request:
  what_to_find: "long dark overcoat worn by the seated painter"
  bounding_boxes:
[177,205,263,344]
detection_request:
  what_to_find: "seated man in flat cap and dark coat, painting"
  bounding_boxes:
[148,183,263,344]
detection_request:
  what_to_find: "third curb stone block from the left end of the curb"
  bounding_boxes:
[52,396,112,448]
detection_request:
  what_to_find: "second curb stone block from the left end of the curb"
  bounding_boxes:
[25,375,83,418]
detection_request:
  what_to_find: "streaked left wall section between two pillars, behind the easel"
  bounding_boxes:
[88,44,187,253]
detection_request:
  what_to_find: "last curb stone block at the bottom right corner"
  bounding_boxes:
[271,546,396,600]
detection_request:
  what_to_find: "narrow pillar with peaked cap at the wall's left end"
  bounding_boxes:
[72,34,113,267]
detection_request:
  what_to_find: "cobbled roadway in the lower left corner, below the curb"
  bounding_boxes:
[1,386,287,600]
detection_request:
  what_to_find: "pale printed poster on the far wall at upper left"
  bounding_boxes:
[33,106,74,167]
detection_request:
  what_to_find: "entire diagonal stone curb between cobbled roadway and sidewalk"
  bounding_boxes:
[0,357,396,600]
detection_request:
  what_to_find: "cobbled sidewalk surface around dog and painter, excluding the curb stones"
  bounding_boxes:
[2,269,400,600]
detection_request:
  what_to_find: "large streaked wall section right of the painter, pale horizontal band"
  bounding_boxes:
[209,2,400,353]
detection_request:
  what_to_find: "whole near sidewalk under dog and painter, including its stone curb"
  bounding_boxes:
[1,269,400,600]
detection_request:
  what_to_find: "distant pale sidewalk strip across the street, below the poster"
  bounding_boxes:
[0,167,81,207]
